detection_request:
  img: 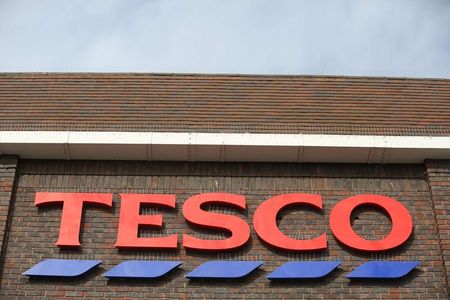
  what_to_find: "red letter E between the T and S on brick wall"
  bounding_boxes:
[115,194,178,249]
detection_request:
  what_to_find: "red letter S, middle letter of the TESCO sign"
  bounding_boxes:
[183,193,250,250]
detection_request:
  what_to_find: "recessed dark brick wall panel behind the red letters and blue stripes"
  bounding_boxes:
[1,160,448,299]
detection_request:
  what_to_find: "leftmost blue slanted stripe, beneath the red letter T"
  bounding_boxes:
[22,259,102,277]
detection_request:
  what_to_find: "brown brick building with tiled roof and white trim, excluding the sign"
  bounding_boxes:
[0,73,450,299]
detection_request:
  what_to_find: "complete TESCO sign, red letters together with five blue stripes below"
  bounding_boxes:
[23,192,420,280]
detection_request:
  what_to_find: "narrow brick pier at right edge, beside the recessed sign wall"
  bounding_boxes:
[426,160,450,293]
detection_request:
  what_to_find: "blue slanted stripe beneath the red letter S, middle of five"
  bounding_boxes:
[186,260,264,279]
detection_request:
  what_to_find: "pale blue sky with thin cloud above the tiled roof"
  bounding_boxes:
[0,0,450,78]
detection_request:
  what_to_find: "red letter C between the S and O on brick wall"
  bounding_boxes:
[253,194,327,251]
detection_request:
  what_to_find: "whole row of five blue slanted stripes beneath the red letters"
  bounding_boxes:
[23,259,420,280]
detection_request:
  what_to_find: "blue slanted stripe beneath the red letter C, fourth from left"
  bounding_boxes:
[266,260,341,280]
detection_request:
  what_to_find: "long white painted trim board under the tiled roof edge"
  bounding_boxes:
[0,131,450,163]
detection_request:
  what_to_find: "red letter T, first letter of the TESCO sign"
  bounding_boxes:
[35,192,112,247]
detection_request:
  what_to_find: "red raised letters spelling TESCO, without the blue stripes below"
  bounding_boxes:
[35,192,413,252]
